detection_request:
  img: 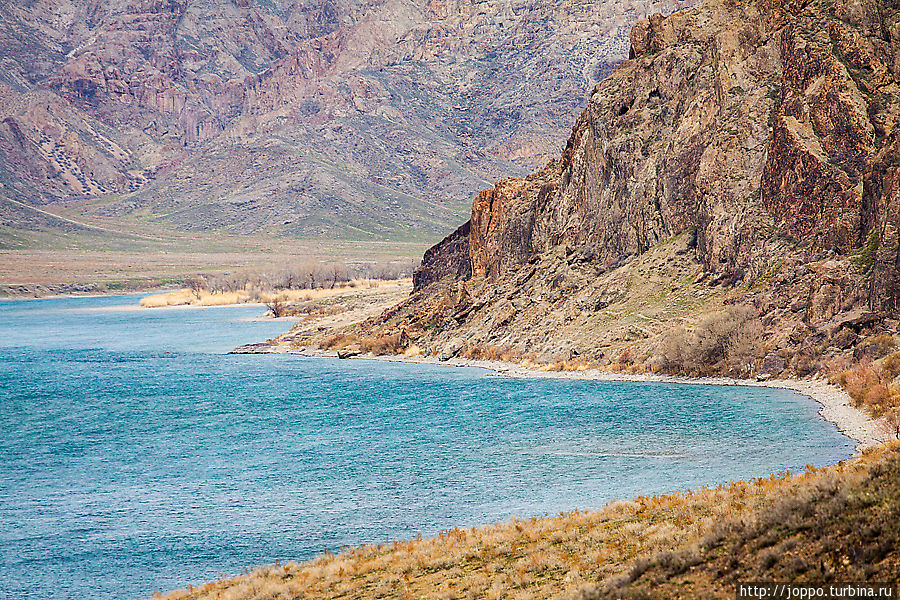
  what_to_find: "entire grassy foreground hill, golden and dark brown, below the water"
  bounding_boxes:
[163,443,900,600]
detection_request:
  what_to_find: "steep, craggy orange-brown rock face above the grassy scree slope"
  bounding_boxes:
[420,0,900,318]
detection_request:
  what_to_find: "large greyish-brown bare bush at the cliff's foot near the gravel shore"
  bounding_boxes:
[660,305,765,375]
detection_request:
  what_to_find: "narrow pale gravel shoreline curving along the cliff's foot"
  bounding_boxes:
[231,343,891,456]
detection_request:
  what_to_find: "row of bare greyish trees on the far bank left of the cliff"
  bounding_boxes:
[185,259,418,293]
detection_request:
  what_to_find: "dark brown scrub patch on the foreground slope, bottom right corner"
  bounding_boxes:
[579,443,900,600]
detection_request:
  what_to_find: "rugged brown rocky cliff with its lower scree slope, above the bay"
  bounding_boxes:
[356,0,900,374]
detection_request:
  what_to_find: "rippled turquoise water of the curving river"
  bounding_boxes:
[0,297,852,600]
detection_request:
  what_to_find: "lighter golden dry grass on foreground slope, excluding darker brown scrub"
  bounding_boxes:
[151,446,900,600]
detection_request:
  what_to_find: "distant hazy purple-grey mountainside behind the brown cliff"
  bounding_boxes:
[0,0,682,245]
